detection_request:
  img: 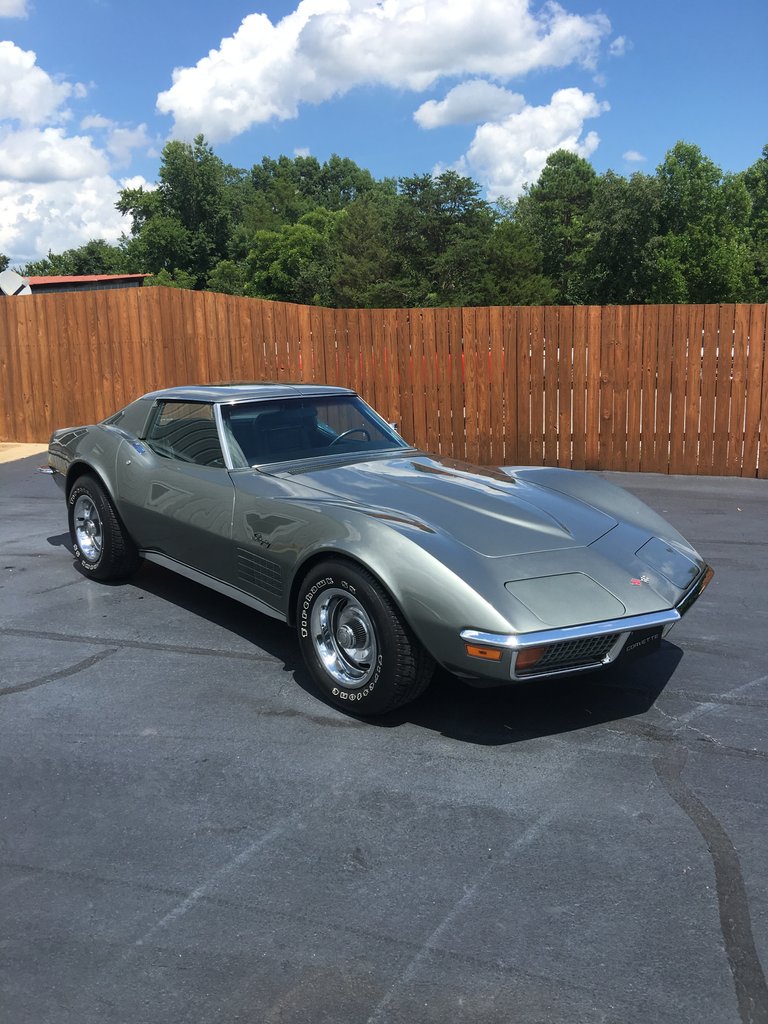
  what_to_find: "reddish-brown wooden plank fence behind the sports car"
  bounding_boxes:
[0,288,768,477]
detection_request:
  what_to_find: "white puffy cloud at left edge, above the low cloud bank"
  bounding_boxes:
[0,40,82,125]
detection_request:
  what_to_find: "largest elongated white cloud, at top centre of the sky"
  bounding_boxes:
[158,0,610,142]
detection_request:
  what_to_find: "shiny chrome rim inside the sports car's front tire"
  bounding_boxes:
[310,588,378,689]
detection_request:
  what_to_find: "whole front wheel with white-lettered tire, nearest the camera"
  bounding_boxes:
[296,561,434,715]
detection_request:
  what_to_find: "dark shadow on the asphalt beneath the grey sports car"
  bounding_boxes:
[113,563,682,745]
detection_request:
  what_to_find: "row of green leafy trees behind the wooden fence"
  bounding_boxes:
[20,135,768,307]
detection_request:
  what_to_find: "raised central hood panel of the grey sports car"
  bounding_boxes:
[272,454,617,557]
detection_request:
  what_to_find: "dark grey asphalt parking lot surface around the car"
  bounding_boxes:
[0,457,768,1024]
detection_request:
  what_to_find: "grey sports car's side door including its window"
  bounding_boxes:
[117,401,234,580]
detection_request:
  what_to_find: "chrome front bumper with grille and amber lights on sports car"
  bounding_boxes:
[461,565,715,682]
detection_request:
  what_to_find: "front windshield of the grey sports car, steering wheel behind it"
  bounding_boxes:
[221,394,410,468]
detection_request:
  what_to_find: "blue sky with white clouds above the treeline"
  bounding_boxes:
[0,0,768,263]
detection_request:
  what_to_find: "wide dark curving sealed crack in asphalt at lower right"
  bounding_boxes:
[653,736,768,1024]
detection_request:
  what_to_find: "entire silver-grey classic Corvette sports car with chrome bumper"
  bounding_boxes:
[48,384,712,715]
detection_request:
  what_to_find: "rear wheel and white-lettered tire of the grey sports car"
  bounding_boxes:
[67,475,138,581]
